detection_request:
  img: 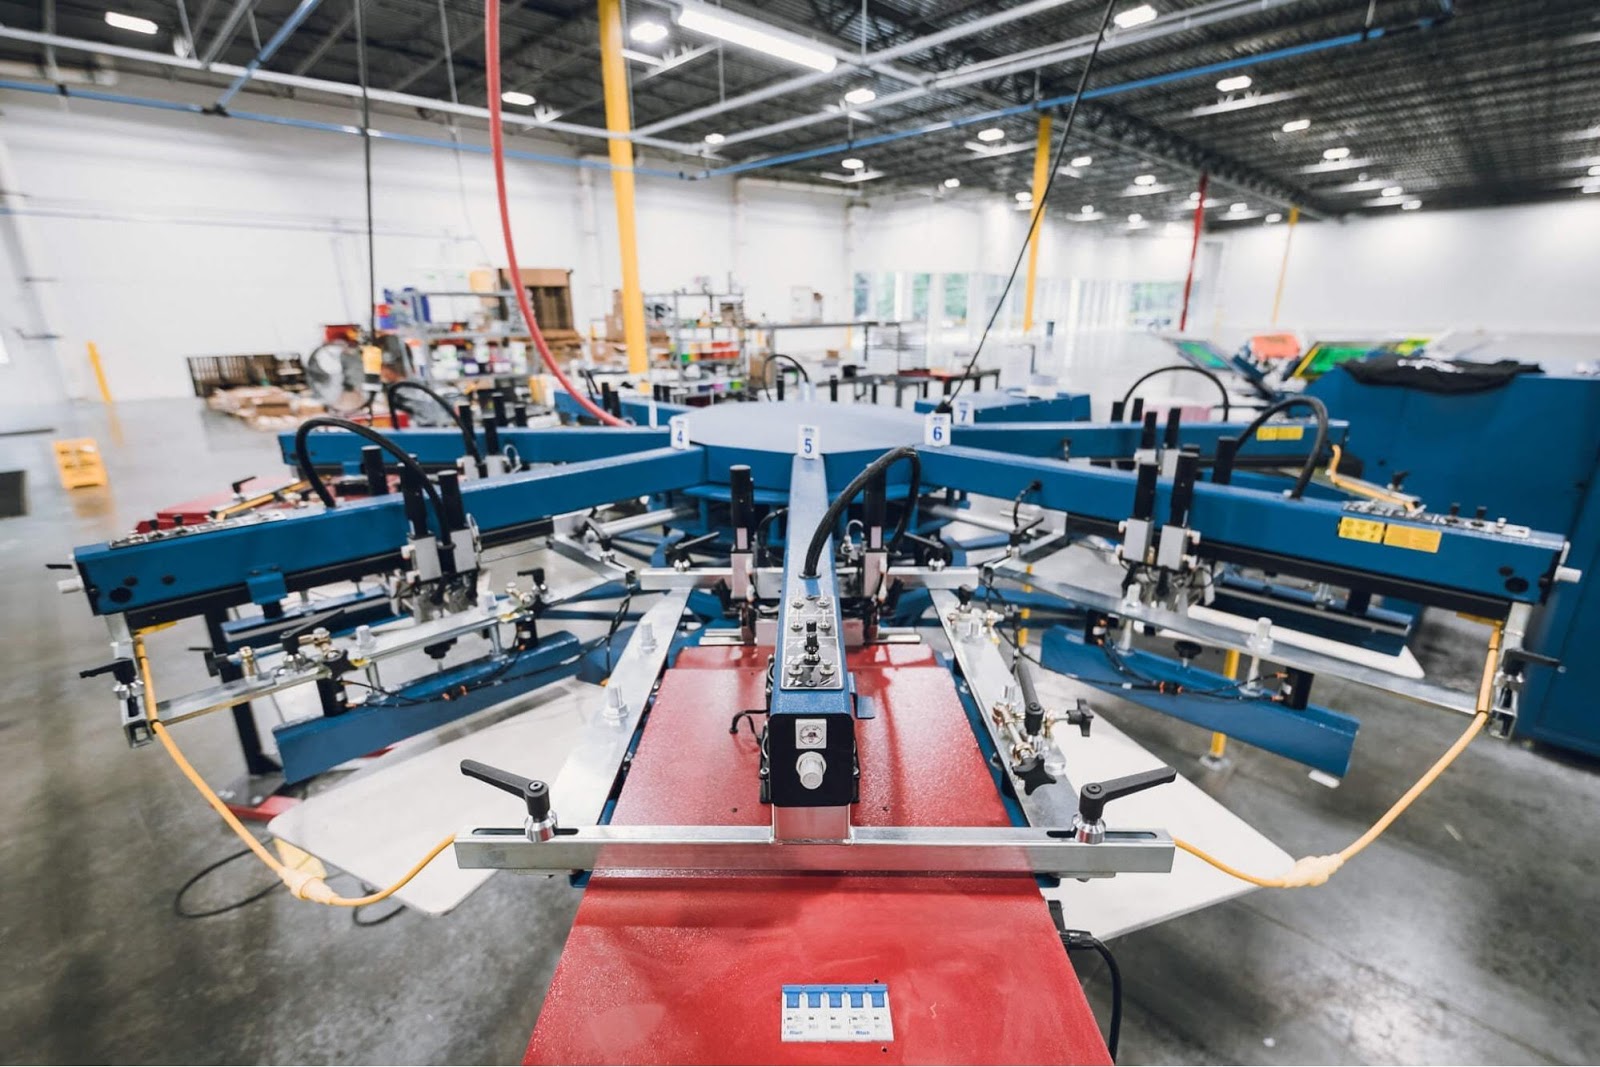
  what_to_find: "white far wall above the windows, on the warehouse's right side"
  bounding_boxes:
[853,190,1600,344]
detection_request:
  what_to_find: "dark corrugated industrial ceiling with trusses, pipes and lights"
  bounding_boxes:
[0,0,1600,227]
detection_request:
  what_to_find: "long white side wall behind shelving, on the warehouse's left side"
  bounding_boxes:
[0,78,848,400]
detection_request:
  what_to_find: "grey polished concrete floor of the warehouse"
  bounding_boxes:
[0,395,1600,1064]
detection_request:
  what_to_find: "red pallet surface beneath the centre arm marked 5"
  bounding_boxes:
[525,645,1110,1064]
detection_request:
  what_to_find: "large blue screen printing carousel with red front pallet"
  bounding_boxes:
[75,402,1576,1062]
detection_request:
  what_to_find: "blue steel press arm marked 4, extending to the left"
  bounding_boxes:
[74,448,706,622]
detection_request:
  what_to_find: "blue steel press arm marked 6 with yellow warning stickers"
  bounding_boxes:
[920,446,1566,608]
